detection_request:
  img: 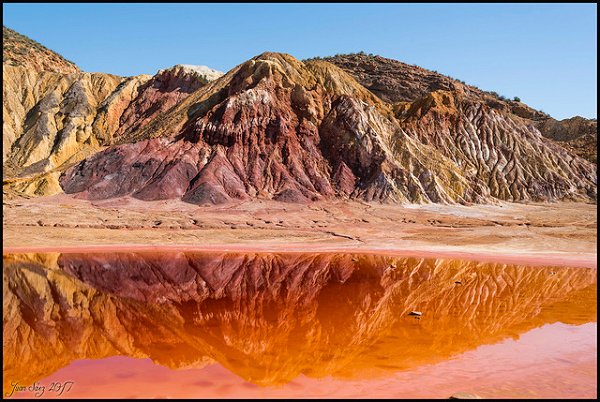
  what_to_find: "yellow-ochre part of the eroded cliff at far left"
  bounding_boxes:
[3,65,145,195]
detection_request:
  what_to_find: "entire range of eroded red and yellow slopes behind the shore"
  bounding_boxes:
[3,27,596,204]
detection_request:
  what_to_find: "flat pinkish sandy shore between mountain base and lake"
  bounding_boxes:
[3,195,597,267]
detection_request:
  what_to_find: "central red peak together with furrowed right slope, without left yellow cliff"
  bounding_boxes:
[60,53,596,204]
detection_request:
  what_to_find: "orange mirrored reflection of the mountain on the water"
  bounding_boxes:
[3,253,596,387]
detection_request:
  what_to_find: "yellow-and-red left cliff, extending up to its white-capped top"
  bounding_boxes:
[3,65,223,195]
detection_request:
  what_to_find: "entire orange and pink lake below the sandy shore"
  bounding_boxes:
[4,253,597,398]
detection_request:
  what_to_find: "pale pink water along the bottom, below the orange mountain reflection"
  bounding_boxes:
[8,323,597,398]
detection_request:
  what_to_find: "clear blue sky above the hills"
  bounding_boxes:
[3,4,597,119]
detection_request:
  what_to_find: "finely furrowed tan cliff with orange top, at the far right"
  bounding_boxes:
[397,91,597,201]
